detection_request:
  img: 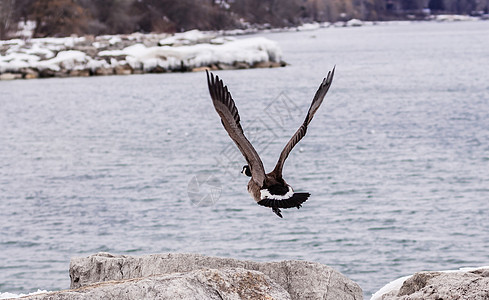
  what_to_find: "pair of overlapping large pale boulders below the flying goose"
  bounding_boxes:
[20,253,363,300]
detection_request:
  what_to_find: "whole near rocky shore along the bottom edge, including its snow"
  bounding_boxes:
[0,252,489,300]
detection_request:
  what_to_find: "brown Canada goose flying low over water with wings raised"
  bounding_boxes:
[206,68,335,218]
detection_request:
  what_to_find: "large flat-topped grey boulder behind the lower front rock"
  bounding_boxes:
[70,253,363,300]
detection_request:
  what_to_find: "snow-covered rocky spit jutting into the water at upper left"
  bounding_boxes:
[0,30,286,80]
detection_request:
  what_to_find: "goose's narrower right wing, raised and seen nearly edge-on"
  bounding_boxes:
[273,68,335,177]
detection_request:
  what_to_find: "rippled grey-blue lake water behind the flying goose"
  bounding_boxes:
[0,22,489,296]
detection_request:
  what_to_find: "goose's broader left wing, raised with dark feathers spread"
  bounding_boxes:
[206,71,265,186]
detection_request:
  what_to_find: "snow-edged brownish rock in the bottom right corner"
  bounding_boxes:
[372,268,489,300]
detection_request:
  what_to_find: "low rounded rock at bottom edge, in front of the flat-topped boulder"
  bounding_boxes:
[26,268,290,300]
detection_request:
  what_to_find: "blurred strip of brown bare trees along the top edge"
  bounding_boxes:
[0,0,478,39]
